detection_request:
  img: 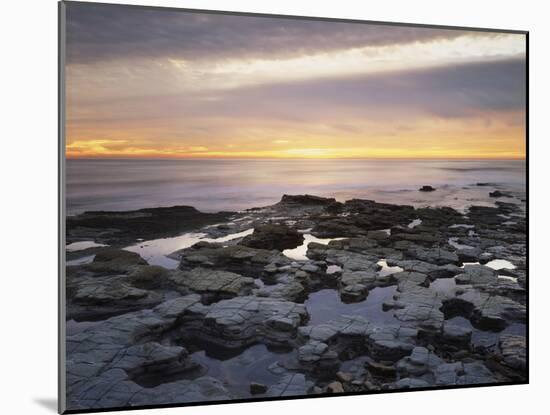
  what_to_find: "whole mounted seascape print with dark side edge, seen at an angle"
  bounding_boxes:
[59,1,528,413]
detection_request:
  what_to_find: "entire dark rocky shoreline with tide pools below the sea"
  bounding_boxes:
[67,188,528,410]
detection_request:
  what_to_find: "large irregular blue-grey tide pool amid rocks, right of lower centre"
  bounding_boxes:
[304,285,398,325]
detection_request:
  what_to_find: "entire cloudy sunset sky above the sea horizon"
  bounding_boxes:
[66,2,526,158]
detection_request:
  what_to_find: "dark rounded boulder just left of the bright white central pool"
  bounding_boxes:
[239,224,304,251]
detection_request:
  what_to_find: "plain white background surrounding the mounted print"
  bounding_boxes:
[0,0,550,415]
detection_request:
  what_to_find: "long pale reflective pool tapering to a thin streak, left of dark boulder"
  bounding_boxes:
[124,229,254,269]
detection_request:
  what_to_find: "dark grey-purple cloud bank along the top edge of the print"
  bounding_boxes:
[67,3,496,63]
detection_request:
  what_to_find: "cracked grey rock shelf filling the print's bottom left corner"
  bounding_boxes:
[66,296,212,409]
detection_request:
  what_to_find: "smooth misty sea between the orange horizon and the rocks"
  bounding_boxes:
[66,159,526,215]
